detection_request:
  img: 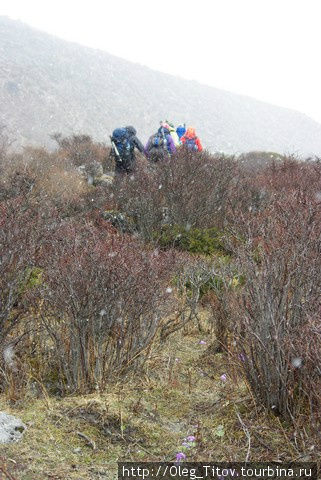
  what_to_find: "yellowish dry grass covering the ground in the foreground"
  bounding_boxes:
[0,316,320,480]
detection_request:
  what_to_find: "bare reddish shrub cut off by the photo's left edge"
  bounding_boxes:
[0,191,51,397]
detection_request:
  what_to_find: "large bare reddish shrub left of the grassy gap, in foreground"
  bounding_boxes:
[31,222,175,391]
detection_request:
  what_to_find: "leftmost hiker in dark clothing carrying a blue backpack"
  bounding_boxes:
[110,126,144,174]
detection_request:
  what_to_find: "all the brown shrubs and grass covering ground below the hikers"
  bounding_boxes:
[0,131,321,480]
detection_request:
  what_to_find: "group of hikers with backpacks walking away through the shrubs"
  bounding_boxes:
[110,120,203,173]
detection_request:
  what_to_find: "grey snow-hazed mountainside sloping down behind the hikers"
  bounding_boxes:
[0,17,321,155]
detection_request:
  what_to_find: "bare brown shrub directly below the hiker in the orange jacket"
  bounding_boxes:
[115,149,237,238]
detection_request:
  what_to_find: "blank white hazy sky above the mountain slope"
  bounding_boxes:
[0,0,321,122]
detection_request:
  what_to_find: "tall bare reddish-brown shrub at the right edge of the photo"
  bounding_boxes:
[225,161,321,428]
